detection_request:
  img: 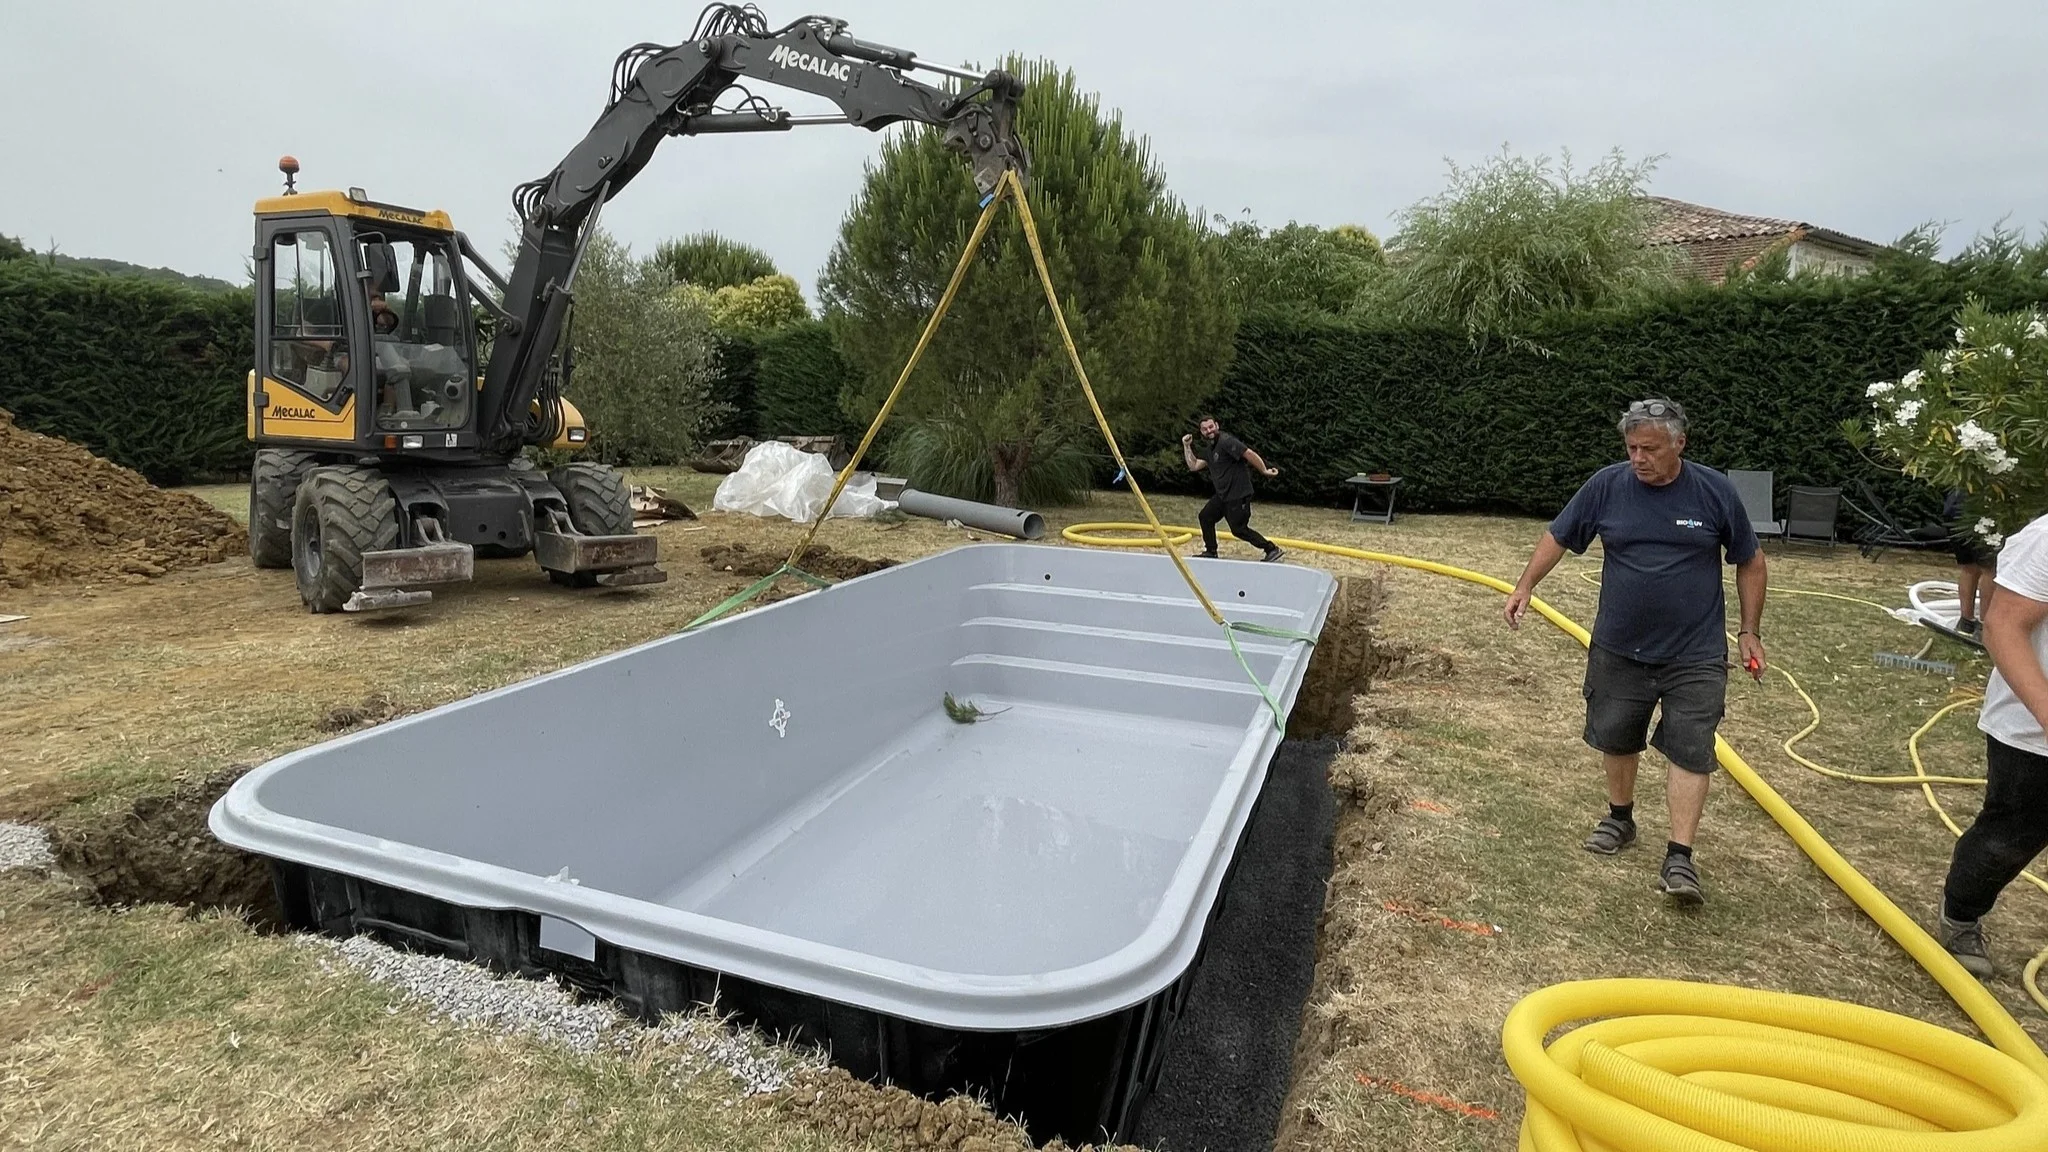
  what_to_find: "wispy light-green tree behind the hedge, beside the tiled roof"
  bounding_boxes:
[1391,152,1675,340]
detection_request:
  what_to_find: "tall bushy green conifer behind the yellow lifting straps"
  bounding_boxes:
[819,61,1235,504]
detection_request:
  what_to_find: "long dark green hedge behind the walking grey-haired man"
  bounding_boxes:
[1139,262,2048,517]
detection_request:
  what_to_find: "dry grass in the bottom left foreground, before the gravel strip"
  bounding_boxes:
[0,873,909,1152]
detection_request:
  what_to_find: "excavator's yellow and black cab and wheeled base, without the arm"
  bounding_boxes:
[248,158,647,611]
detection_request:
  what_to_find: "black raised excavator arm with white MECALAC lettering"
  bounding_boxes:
[479,4,1026,453]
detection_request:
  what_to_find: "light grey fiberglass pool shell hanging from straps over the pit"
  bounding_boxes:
[211,543,1335,1031]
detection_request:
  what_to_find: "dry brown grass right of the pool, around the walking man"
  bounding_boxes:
[1266,506,2048,1150]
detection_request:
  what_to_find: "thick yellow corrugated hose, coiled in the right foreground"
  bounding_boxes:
[1063,523,2048,1152]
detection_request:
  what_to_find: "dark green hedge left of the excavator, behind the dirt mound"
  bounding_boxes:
[0,260,256,484]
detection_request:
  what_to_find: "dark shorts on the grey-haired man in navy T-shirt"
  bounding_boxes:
[1585,644,1729,775]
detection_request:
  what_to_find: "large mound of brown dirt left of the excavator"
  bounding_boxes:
[0,408,248,588]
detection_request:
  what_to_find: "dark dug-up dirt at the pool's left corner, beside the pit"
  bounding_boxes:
[49,765,276,920]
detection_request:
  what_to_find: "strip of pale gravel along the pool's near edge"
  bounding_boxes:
[299,937,815,1095]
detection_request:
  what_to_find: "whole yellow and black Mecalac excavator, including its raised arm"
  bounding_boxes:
[248,4,1026,613]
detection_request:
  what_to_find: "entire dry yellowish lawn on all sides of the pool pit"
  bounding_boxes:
[0,469,2048,1150]
